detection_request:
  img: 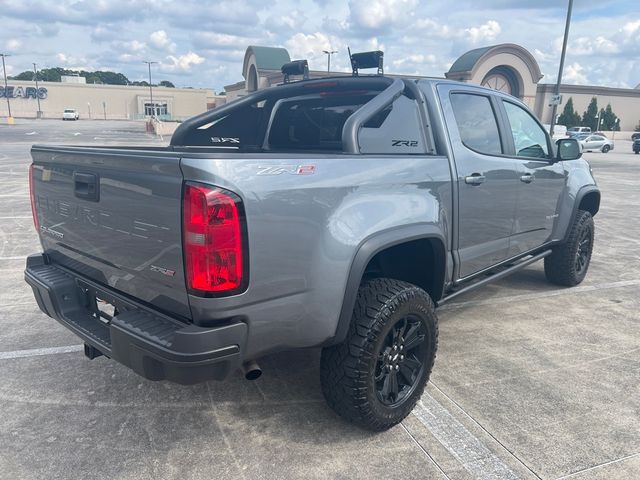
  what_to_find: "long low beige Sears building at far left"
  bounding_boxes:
[0,80,218,120]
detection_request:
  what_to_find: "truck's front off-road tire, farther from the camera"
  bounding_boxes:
[544,210,595,287]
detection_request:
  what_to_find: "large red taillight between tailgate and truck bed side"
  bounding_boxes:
[183,183,245,294]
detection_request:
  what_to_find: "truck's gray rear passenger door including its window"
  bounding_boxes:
[438,85,519,278]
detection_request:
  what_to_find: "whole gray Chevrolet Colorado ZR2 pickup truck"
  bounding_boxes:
[25,75,600,430]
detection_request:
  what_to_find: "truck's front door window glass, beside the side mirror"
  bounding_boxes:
[503,101,549,158]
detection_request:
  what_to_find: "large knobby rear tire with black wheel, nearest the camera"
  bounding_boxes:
[320,278,438,431]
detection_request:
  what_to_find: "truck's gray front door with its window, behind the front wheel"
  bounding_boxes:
[501,99,565,257]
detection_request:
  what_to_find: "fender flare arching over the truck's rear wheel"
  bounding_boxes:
[327,224,447,345]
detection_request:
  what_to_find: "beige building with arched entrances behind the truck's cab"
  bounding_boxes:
[225,43,640,131]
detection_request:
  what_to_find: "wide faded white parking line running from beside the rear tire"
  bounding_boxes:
[413,393,520,480]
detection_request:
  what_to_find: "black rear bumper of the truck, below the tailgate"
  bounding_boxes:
[25,254,247,384]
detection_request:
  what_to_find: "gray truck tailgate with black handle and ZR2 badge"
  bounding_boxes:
[31,146,191,319]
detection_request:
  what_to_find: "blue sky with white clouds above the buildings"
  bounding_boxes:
[0,0,640,90]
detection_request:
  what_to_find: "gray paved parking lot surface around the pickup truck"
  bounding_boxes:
[0,120,640,480]
